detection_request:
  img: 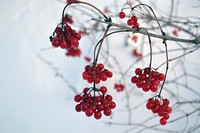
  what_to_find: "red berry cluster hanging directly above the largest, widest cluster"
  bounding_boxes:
[82,63,113,84]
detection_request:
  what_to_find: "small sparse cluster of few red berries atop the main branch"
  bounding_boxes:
[118,11,139,28]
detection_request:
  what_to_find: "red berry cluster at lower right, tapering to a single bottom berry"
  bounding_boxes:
[146,97,172,125]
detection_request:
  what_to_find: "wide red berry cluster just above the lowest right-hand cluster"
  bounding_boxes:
[131,68,165,92]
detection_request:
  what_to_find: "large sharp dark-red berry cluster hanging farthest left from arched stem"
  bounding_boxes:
[50,24,81,49]
